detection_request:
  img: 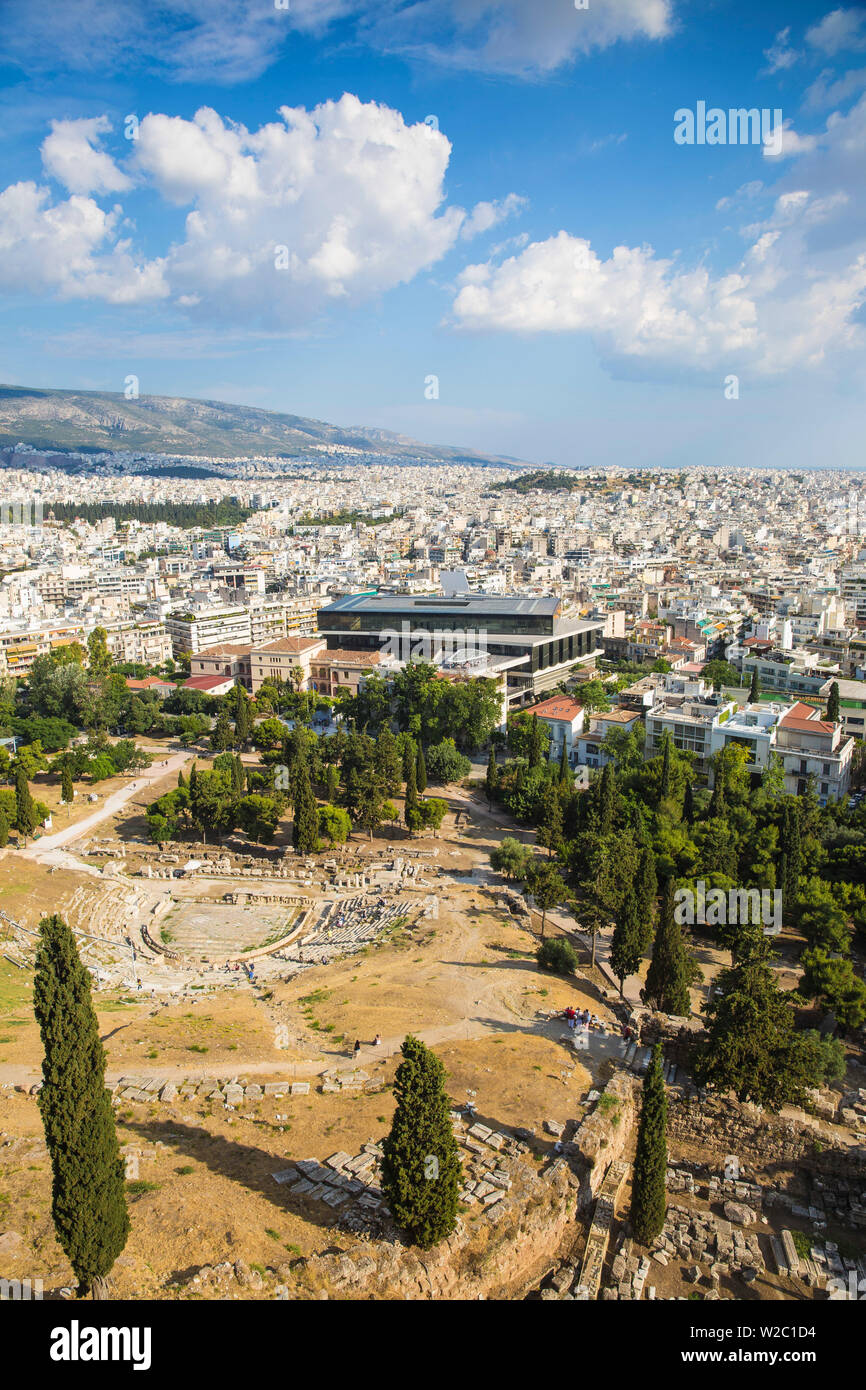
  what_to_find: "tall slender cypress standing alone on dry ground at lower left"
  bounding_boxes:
[33,916,129,1298]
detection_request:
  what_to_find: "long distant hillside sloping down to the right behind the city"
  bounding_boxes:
[0,386,518,464]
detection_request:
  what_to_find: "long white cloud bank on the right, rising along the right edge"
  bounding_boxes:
[452,97,866,374]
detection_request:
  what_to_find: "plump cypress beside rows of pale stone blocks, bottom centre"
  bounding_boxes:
[382,1036,461,1250]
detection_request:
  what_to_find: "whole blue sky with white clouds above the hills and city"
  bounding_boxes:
[0,0,866,468]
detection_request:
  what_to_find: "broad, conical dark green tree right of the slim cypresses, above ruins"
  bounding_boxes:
[695,938,820,1111]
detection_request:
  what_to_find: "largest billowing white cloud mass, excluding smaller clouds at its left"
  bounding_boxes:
[135,95,475,327]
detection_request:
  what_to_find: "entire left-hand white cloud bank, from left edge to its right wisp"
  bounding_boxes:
[0,95,524,329]
